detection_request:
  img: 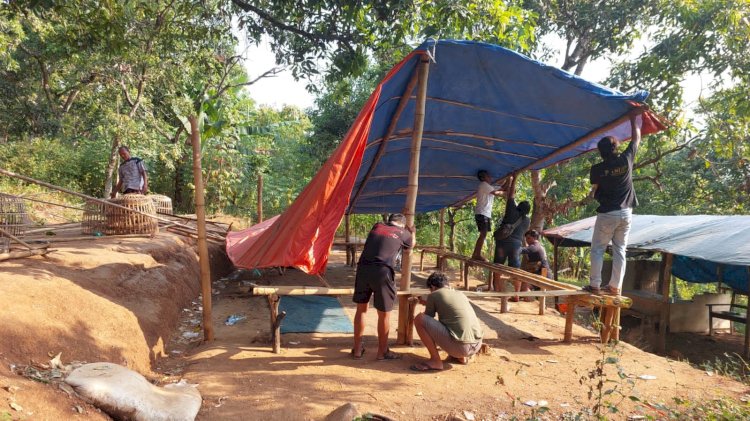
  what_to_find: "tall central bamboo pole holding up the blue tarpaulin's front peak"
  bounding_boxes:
[397,56,430,344]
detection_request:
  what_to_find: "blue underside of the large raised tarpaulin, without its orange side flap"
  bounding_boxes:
[347,40,664,213]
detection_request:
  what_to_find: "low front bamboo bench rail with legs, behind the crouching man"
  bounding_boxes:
[252,286,588,354]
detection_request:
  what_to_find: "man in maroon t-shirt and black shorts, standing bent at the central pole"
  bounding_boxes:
[351,213,414,360]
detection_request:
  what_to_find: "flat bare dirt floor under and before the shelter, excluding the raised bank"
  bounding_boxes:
[170,252,746,420]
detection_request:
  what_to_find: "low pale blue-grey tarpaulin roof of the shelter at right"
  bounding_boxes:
[543,215,750,292]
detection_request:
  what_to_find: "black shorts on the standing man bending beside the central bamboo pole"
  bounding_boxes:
[352,265,396,311]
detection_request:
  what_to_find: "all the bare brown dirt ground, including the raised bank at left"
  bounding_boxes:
[0,234,748,420]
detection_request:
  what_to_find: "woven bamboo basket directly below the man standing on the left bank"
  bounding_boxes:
[104,194,159,235]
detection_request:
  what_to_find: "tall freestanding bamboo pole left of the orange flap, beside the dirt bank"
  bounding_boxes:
[191,115,214,342]
